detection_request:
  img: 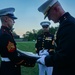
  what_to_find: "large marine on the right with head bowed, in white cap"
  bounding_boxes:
[37,0,75,75]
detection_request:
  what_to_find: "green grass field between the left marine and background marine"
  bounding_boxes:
[17,42,38,75]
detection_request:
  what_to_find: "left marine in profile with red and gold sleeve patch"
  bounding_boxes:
[0,7,33,75]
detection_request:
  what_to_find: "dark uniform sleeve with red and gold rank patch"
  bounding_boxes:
[1,34,23,63]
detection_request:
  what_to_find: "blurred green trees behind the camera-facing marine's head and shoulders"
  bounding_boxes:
[23,27,58,41]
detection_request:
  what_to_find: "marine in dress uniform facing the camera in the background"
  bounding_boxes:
[35,21,54,75]
